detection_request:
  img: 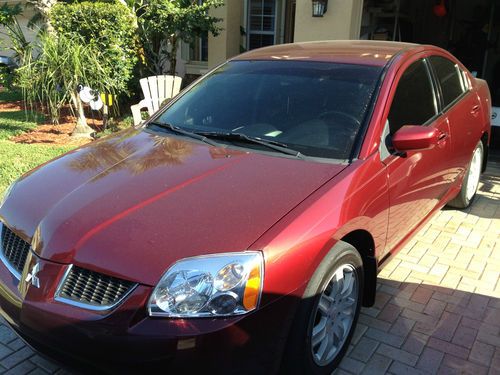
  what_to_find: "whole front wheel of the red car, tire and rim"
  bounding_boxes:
[283,242,364,374]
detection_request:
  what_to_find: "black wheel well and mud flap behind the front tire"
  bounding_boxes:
[340,229,377,307]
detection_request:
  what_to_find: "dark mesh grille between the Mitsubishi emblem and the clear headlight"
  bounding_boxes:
[57,266,137,308]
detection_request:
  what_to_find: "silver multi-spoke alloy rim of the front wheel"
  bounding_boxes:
[311,264,359,366]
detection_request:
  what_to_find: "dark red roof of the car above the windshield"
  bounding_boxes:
[231,40,425,66]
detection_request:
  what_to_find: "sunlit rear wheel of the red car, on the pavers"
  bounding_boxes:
[448,141,484,208]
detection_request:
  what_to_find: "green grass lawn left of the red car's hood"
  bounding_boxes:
[0,104,74,197]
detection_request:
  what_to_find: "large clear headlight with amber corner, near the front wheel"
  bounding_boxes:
[148,251,264,318]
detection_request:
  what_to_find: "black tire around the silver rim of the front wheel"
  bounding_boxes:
[282,241,364,375]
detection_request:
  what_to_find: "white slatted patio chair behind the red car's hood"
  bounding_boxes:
[130,75,182,125]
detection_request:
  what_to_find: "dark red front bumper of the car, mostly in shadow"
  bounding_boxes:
[0,252,296,374]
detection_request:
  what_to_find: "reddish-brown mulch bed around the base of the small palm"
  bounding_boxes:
[0,101,102,146]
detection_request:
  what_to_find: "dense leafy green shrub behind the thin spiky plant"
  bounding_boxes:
[50,1,137,93]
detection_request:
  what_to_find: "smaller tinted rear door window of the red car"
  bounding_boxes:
[429,56,465,107]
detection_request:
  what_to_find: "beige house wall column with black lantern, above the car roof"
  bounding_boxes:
[294,0,363,42]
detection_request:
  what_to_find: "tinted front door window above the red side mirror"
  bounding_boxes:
[388,60,436,134]
